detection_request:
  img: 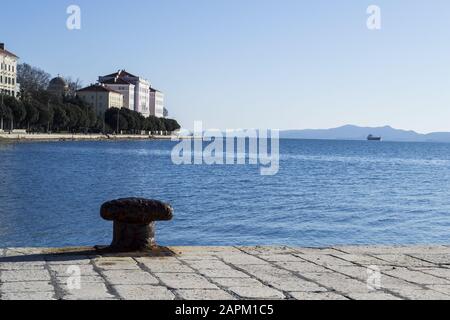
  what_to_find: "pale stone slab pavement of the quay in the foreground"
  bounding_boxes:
[0,246,450,300]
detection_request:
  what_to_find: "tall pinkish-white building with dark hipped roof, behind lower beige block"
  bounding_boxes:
[98,70,150,117]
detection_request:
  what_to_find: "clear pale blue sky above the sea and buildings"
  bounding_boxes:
[0,0,450,132]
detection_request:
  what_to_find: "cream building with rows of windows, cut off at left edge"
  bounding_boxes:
[0,43,20,97]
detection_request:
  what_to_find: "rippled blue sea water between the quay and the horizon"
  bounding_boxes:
[0,140,450,247]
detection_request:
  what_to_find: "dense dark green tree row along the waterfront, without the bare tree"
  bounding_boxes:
[0,93,180,134]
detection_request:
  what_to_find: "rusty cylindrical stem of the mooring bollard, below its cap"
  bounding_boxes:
[109,221,156,252]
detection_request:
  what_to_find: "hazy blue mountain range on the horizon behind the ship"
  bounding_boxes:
[280,125,450,142]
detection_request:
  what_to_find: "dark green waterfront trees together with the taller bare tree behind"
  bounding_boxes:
[0,65,180,134]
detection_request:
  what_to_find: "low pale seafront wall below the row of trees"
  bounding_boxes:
[0,133,173,141]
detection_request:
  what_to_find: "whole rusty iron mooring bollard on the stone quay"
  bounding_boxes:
[100,198,173,252]
